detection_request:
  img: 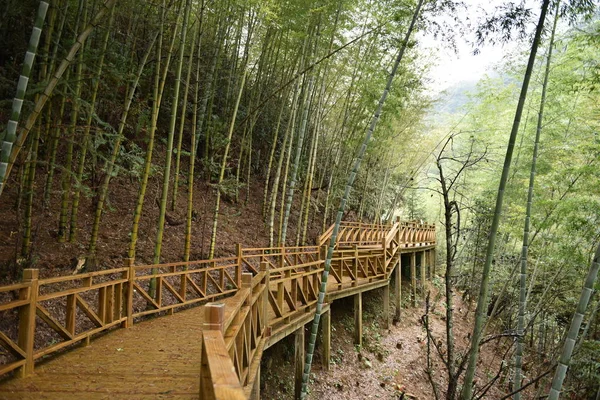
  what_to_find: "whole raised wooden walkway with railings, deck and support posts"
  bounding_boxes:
[0,221,435,400]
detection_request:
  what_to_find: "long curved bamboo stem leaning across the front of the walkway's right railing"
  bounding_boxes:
[300,0,424,398]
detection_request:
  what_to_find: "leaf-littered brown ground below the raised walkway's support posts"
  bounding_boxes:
[261,278,506,400]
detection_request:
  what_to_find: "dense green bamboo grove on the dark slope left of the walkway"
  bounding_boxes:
[2,0,427,271]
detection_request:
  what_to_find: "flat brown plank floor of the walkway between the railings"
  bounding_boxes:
[0,307,210,400]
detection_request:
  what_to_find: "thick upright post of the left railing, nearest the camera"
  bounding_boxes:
[18,268,39,378]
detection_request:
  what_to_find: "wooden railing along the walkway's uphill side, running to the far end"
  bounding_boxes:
[0,221,435,382]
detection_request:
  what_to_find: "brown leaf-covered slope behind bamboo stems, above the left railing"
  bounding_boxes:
[0,150,324,285]
